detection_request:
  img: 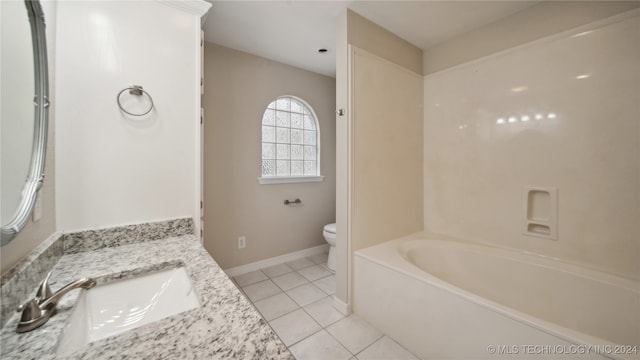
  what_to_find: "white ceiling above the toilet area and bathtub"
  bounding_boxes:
[204,0,537,76]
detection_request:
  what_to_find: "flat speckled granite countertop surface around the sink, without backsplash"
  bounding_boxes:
[0,229,293,359]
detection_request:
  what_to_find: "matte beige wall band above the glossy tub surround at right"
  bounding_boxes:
[423,1,640,75]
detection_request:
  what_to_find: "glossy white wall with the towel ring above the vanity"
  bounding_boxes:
[56,1,209,231]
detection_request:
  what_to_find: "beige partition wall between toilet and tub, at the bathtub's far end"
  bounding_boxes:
[336,10,422,310]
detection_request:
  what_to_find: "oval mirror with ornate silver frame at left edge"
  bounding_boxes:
[0,0,49,245]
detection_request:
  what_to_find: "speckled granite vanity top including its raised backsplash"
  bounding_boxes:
[0,219,293,359]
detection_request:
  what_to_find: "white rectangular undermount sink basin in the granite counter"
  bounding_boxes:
[58,267,200,354]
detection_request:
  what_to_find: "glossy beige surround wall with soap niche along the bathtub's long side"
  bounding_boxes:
[424,10,640,279]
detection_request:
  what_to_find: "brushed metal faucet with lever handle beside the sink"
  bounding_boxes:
[16,273,96,333]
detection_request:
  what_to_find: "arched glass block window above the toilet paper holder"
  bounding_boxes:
[262,96,320,177]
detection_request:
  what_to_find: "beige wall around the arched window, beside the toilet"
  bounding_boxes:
[203,43,336,268]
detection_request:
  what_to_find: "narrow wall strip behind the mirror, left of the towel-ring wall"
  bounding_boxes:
[0,2,57,273]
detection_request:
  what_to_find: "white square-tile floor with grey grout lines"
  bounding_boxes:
[233,254,417,360]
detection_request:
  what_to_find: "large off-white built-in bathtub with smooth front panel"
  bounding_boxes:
[353,236,640,359]
